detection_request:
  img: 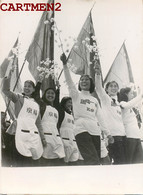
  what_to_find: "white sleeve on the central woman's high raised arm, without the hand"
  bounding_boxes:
[64,65,78,99]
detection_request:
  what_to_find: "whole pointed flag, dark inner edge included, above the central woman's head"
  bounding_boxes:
[67,11,102,103]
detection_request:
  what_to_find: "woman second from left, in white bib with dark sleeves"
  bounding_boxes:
[36,76,65,166]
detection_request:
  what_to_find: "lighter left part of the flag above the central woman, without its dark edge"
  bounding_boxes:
[67,11,95,75]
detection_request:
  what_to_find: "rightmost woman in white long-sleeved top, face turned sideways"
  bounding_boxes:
[119,87,143,164]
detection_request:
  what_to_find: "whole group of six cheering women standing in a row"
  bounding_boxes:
[2,54,143,166]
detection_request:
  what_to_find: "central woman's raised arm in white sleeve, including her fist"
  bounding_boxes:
[61,53,78,99]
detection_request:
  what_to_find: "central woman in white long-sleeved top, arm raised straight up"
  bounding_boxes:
[61,54,113,165]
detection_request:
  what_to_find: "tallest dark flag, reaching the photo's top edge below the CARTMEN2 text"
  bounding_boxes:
[25,0,54,93]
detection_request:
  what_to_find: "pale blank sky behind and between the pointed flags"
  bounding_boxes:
[0,0,143,111]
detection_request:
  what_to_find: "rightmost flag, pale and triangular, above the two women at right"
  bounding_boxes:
[104,43,134,89]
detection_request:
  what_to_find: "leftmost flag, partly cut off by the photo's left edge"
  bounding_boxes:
[0,39,22,120]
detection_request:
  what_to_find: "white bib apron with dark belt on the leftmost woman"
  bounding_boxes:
[15,98,43,160]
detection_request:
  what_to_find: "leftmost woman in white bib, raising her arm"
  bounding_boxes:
[2,70,46,166]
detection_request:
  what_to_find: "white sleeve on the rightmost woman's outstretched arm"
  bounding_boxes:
[120,95,142,109]
